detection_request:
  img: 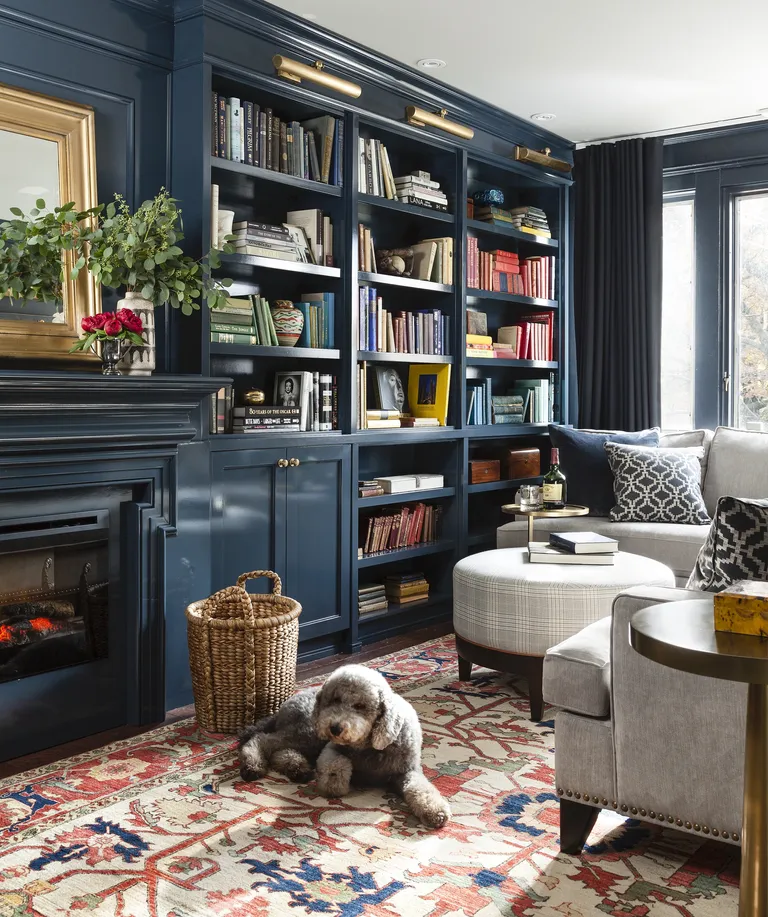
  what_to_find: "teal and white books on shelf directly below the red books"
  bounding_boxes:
[466,373,555,426]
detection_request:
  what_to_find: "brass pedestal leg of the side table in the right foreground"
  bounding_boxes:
[739,685,768,917]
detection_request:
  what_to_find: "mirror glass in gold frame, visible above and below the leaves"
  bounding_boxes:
[0,130,64,322]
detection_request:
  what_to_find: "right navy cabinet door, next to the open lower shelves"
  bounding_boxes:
[286,446,352,640]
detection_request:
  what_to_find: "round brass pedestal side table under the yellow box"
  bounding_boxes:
[629,598,768,917]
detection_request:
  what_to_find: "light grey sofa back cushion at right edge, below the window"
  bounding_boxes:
[703,427,768,515]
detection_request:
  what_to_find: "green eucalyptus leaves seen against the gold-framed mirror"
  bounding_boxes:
[0,199,102,302]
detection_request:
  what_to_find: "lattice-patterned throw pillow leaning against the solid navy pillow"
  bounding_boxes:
[603,443,709,525]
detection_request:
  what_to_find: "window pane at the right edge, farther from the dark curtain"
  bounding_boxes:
[732,191,768,432]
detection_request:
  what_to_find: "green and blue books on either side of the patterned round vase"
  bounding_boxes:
[211,293,335,348]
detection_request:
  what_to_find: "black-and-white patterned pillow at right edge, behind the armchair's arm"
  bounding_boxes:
[686,497,768,592]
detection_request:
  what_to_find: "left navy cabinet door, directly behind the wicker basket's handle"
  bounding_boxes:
[211,449,293,592]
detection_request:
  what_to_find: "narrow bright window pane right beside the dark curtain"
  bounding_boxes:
[661,196,696,430]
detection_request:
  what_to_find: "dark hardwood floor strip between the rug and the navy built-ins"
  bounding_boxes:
[0,622,452,779]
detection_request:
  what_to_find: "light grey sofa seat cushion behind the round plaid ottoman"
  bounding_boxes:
[496,516,709,586]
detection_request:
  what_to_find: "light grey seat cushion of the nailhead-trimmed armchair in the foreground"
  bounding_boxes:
[543,616,611,716]
